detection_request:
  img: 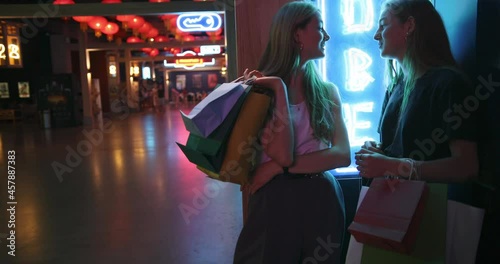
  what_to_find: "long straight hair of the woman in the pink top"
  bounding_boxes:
[258,1,335,143]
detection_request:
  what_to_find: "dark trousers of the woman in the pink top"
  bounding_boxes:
[234,174,345,264]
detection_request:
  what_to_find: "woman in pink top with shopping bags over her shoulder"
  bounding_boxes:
[234,1,350,264]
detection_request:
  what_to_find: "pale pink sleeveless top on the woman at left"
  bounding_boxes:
[261,101,328,162]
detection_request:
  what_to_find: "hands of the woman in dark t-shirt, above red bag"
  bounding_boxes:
[354,148,398,178]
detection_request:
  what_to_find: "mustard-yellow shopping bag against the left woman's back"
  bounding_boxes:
[201,86,273,184]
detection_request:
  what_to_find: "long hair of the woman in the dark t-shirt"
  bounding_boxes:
[383,0,457,111]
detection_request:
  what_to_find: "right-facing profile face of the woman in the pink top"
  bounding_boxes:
[296,14,330,62]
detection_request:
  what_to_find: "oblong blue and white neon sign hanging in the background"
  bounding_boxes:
[177,12,222,32]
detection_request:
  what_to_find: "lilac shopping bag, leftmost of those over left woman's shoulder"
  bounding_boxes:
[181,83,248,137]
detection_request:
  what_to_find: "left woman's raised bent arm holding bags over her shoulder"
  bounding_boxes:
[254,77,294,167]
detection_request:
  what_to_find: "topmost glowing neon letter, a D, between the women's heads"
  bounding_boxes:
[341,0,374,35]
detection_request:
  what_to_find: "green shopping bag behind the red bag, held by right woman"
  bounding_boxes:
[361,183,448,264]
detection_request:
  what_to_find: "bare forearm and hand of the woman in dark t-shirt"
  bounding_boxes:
[356,140,479,183]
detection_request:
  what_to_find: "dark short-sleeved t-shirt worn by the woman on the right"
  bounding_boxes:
[380,68,478,160]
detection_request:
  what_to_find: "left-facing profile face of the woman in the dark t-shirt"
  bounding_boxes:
[373,10,406,62]
